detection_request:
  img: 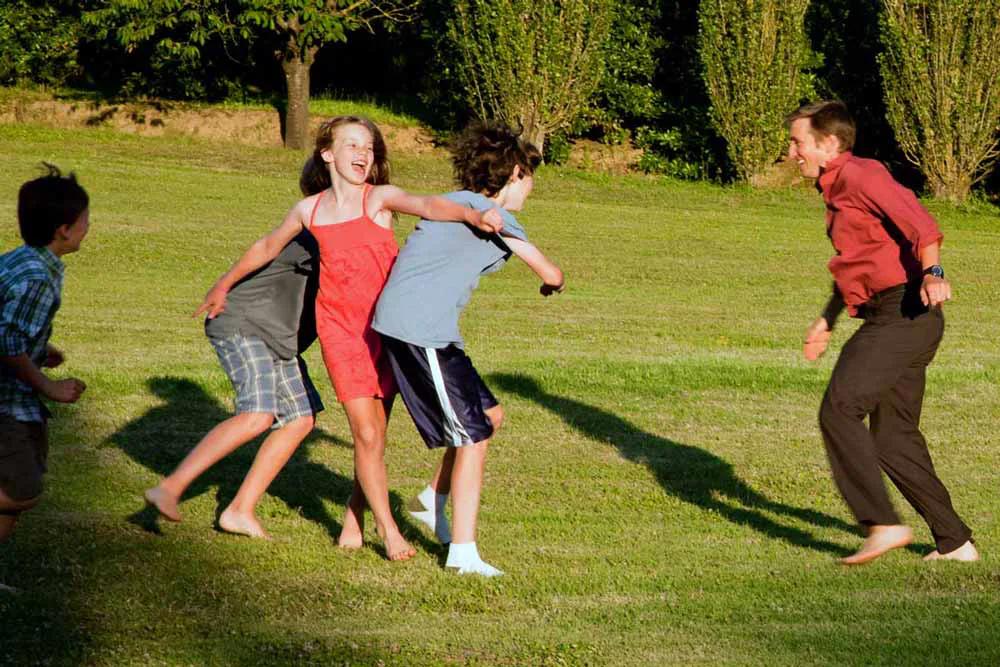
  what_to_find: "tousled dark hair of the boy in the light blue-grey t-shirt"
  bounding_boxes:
[451,121,542,197]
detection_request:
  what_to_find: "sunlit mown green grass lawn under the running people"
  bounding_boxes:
[0,126,1000,666]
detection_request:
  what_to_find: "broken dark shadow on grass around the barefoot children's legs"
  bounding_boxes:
[107,377,441,554]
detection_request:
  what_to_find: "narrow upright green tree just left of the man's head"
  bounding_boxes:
[699,0,809,182]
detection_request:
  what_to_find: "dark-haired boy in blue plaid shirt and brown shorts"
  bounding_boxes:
[0,165,90,590]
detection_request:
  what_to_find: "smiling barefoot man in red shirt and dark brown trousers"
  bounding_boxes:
[787,102,979,565]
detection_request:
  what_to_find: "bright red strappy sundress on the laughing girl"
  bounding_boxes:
[309,185,399,403]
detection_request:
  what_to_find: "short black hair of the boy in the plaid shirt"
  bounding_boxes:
[17,162,90,248]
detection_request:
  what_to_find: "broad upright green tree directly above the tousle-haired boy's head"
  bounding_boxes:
[449,0,612,153]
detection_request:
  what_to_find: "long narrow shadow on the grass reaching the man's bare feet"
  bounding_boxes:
[489,373,880,556]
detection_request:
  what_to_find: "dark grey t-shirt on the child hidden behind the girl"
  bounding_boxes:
[205,231,319,359]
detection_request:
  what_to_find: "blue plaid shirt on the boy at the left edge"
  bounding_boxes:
[0,245,63,422]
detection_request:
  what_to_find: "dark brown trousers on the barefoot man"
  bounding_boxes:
[819,285,972,553]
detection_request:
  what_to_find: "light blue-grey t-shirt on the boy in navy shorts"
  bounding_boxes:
[372,190,528,348]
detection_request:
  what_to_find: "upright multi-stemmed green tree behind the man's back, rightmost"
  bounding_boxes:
[879,0,1000,201]
